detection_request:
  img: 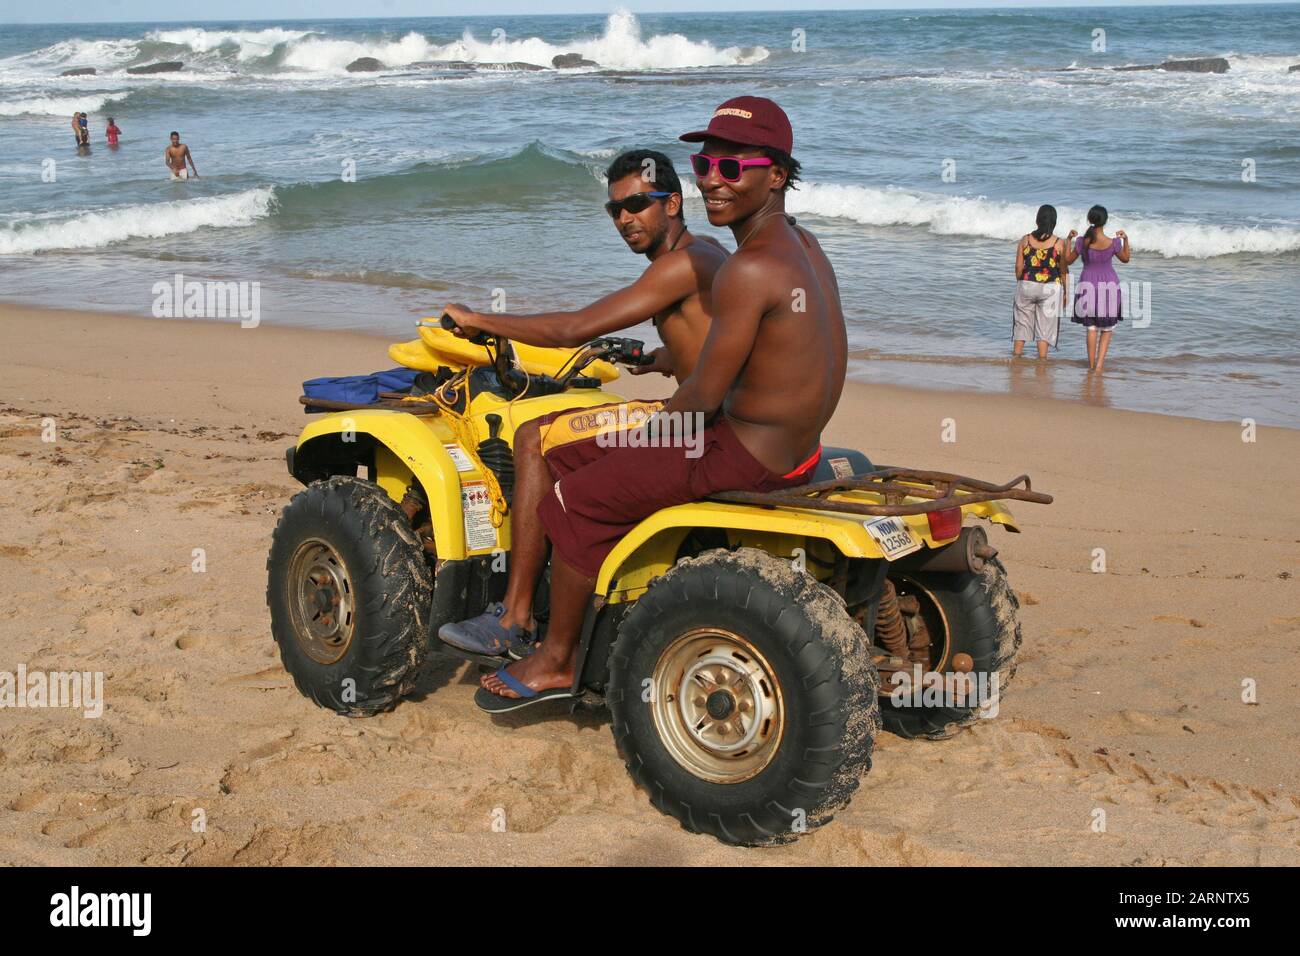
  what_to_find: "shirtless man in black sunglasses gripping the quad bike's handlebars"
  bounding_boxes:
[438,150,727,657]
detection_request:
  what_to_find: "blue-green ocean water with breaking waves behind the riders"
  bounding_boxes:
[0,4,1300,427]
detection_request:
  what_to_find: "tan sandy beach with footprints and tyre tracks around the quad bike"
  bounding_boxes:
[0,306,1300,865]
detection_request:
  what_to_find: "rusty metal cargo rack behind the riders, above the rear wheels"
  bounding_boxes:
[709,467,1052,518]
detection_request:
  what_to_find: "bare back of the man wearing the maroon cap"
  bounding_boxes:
[723,215,848,475]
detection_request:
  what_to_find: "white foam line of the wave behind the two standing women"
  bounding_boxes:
[787,182,1300,259]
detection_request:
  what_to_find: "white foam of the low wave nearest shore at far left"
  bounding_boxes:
[0,187,274,255]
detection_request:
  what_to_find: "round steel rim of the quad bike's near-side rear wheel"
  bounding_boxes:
[651,628,785,783]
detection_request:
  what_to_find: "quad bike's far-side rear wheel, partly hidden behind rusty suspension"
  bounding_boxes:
[880,558,1021,740]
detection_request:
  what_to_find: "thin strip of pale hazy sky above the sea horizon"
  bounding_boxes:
[0,0,1279,23]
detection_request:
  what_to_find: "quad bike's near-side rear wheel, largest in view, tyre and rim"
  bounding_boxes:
[606,549,880,845]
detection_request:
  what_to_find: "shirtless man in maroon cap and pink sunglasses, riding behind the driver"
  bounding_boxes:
[475,96,848,713]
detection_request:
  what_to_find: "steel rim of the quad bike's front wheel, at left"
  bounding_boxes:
[287,538,356,665]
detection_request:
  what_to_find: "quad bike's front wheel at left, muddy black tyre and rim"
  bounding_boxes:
[267,476,433,717]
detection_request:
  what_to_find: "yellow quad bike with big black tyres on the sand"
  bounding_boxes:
[267,320,1052,845]
